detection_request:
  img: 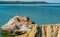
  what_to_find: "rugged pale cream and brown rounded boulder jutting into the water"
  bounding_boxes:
[2,16,34,33]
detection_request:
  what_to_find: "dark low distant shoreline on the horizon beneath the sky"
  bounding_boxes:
[0,1,47,4]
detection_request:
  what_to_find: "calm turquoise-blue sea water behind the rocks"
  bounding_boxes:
[0,4,60,37]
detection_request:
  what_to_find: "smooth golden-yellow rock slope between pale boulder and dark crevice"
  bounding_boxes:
[15,25,37,37]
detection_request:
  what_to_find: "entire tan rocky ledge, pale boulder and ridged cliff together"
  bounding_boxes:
[2,16,60,37]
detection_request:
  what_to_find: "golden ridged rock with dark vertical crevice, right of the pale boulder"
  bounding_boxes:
[15,24,60,37]
